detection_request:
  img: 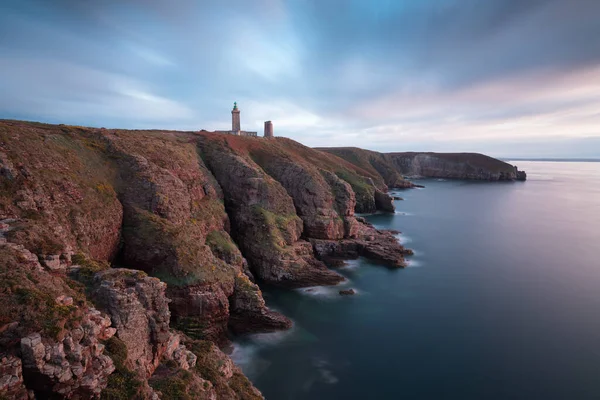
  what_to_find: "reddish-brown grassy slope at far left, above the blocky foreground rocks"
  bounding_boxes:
[0,121,118,254]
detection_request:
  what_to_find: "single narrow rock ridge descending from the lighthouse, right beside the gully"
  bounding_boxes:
[200,134,343,287]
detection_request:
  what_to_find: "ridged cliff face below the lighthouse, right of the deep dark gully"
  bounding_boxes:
[200,134,404,287]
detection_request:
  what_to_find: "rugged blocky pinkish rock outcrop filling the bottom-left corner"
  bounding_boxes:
[0,242,115,398]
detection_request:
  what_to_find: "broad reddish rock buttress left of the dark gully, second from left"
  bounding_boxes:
[103,131,288,343]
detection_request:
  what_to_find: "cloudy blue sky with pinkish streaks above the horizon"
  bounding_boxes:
[0,0,600,158]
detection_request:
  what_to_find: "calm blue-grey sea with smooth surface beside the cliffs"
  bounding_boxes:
[233,161,600,400]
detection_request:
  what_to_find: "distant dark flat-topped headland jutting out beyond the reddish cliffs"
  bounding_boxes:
[319,147,527,183]
